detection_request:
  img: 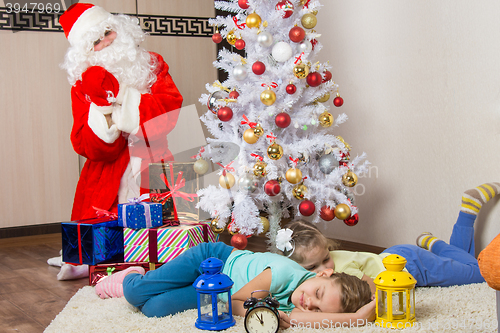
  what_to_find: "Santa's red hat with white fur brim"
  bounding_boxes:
[59,3,111,45]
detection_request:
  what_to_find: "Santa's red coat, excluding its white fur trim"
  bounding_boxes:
[71,53,182,220]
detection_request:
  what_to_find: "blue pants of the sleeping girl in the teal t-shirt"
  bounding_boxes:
[123,242,234,317]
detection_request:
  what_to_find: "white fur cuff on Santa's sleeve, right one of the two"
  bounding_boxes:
[111,87,141,134]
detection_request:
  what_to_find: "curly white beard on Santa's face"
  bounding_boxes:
[88,32,156,92]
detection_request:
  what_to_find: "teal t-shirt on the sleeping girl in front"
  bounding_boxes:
[223,250,316,312]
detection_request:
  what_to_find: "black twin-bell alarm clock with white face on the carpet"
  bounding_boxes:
[243,290,280,333]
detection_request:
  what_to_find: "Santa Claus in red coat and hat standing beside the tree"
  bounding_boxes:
[59,3,182,220]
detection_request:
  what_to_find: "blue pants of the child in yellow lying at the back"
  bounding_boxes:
[384,212,484,287]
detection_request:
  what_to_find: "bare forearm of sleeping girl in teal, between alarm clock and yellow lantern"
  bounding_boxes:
[290,300,375,328]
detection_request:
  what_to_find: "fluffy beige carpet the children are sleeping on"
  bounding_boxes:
[45,283,498,333]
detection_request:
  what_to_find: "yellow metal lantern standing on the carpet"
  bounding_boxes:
[373,254,417,328]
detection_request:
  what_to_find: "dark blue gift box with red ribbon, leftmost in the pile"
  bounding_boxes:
[61,217,123,265]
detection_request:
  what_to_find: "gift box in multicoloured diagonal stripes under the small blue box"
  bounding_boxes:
[123,223,218,263]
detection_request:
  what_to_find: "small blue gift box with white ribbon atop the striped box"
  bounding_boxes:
[118,202,163,229]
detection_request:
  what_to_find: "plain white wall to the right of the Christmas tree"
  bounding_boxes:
[316,0,500,254]
